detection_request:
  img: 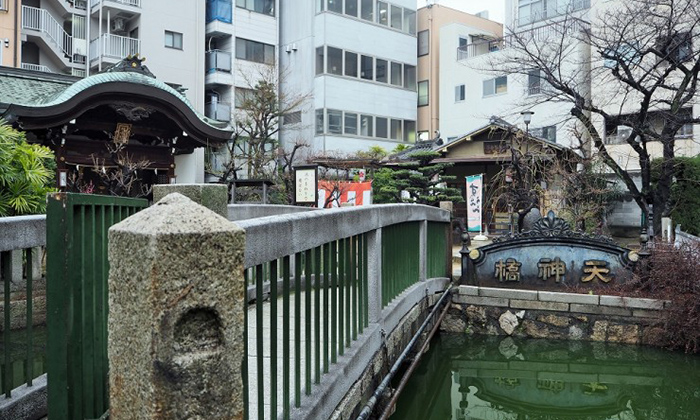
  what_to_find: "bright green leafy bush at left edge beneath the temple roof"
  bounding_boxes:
[0,121,54,216]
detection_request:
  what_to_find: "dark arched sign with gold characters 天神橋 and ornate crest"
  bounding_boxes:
[468,211,639,290]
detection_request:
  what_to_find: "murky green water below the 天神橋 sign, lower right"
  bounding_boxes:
[391,334,700,420]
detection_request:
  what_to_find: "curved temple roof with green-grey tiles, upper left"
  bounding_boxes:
[0,57,232,145]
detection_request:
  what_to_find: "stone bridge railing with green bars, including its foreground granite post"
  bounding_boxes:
[109,189,451,419]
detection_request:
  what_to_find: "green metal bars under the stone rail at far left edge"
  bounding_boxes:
[0,248,46,398]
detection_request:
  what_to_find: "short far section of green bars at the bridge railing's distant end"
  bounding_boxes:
[382,222,420,308]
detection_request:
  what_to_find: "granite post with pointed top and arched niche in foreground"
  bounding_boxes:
[108,193,245,420]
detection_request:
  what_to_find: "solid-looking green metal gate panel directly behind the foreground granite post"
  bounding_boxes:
[46,193,148,419]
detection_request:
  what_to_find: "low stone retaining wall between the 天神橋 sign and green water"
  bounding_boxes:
[441,286,670,345]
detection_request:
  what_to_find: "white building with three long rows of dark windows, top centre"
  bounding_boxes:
[279,0,418,153]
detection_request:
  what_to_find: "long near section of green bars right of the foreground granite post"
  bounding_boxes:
[243,234,369,419]
